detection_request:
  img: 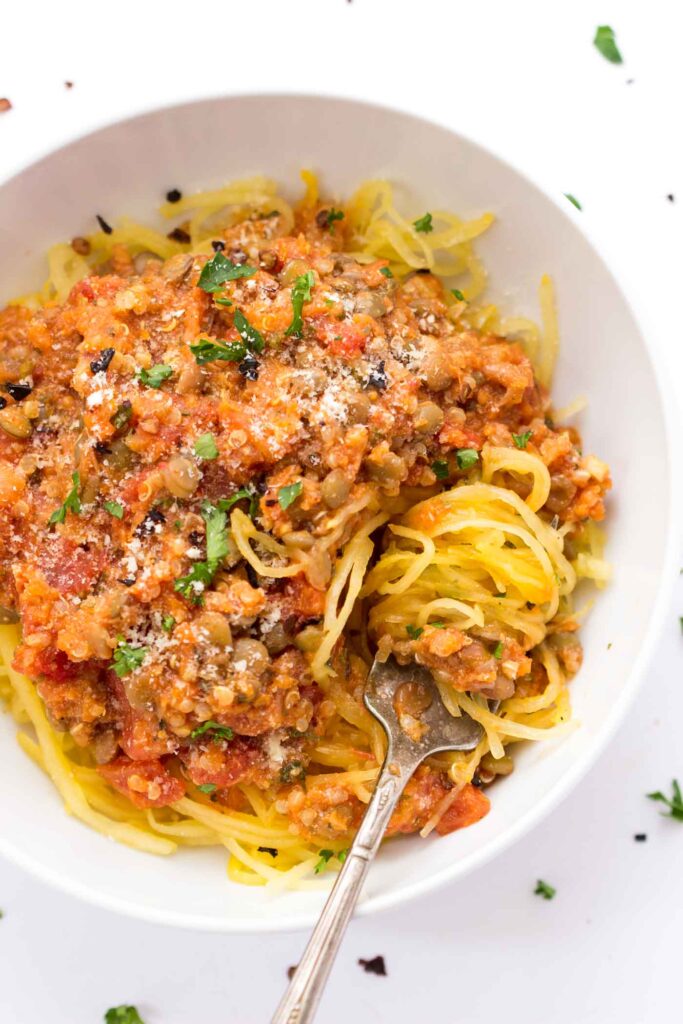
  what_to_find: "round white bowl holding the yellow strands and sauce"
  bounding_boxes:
[0,95,674,931]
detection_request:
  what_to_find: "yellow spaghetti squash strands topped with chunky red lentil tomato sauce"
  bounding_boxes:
[0,172,609,886]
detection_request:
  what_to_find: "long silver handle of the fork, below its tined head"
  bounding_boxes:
[271,751,422,1024]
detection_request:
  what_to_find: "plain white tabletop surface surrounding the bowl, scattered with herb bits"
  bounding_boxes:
[0,0,683,1024]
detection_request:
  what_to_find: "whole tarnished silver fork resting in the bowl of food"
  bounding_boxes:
[271,658,481,1024]
